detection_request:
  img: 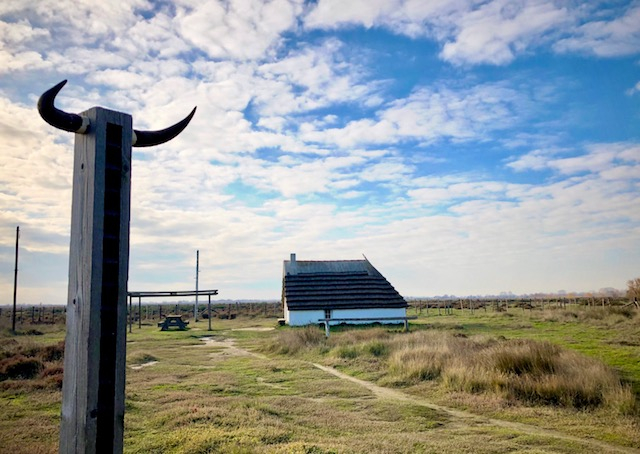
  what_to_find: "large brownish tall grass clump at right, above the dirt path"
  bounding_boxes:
[388,332,635,414]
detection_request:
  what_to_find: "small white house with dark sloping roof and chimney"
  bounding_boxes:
[282,254,407,326]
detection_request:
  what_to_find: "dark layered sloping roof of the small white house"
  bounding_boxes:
[282,255,407,310]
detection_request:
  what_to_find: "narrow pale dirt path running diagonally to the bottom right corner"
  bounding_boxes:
[313,363,640,454]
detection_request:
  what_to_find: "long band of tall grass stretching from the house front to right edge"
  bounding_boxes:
[267,327,636,414]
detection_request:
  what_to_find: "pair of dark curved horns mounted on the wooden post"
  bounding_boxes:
[38,80,197,147]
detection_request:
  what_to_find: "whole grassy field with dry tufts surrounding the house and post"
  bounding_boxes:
[0,307,640,453]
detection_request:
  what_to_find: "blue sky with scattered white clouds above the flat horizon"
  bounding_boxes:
[0,0,640,305]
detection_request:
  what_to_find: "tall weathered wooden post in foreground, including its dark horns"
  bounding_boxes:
[38,80,195,453]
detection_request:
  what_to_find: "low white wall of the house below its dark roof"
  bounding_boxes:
[284,307,407,326]
